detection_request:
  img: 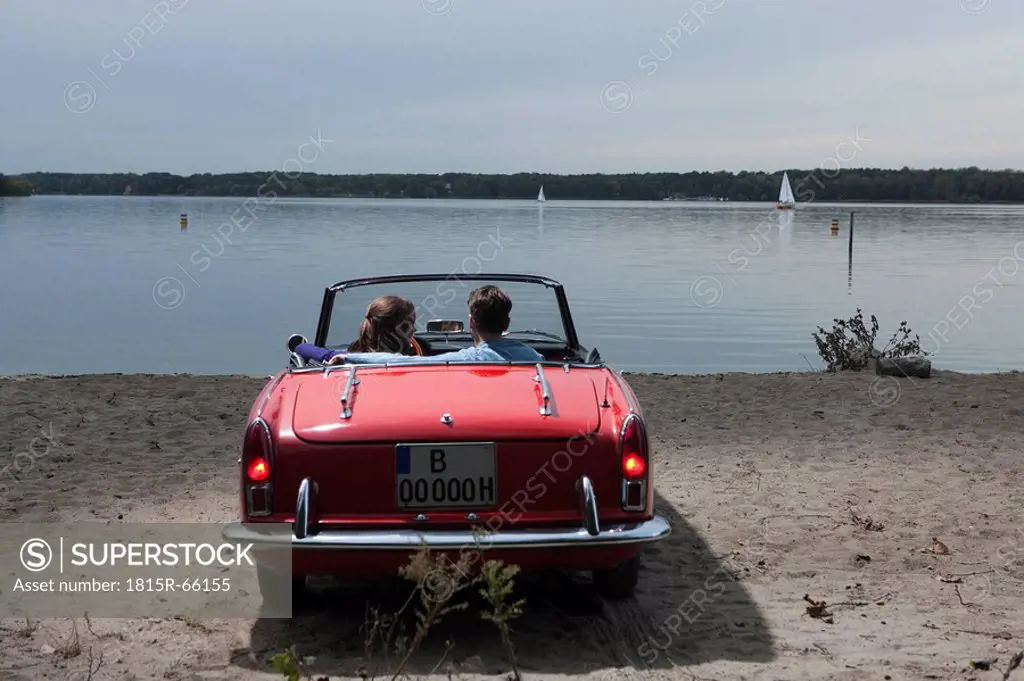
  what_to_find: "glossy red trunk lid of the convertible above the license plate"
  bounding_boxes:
[292,365,600,443]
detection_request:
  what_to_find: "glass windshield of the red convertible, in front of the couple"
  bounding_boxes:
[327,276,565,349]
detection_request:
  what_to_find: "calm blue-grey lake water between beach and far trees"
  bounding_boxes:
[0,197,1024,375]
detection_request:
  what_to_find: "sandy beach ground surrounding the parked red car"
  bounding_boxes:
[0,372,1024,681]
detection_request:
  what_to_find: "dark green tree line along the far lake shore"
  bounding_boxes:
[6,167,1024,203]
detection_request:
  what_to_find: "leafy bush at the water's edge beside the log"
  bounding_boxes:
[811,307,928,372]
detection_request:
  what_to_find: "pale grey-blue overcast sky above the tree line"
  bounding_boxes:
[0,0,1024,174]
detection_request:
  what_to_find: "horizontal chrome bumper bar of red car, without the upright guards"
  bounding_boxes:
[221,515,672,551]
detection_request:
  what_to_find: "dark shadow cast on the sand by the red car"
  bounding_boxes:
[231,496,775,678]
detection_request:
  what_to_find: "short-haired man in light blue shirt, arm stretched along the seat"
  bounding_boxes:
[328,285,544,365]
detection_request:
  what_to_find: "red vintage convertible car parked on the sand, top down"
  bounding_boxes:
[223,274,670,600]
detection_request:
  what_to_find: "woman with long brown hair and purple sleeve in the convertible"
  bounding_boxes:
[292,296,423,364]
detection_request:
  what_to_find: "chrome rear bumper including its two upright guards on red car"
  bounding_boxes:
[222,475,672,551]
